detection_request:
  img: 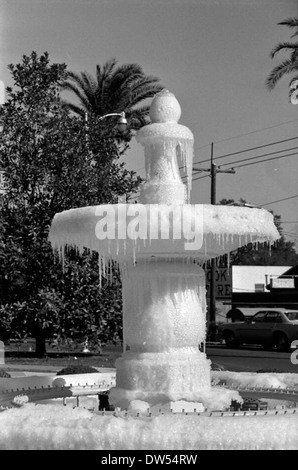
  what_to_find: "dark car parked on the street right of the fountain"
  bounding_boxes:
[219,308,298,351]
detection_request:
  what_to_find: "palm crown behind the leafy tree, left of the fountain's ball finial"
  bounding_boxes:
[62,59,164,133]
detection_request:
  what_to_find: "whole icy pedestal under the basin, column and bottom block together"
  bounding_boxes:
[110,260,210,408]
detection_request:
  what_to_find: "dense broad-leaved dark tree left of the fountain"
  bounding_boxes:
[0,52,141,354]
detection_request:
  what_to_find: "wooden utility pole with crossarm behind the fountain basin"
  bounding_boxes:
[193,142,235,341]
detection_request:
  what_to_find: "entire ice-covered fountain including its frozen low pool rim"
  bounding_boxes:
[0,90,298,450]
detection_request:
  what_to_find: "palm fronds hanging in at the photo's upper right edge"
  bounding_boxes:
[266,18,298,90]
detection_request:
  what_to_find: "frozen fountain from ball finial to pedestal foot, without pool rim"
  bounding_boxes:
[50,90,279,409]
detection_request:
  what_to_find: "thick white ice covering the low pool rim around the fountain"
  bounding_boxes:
[0,371,298,450]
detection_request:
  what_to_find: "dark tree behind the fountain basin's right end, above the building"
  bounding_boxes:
[220,199,298,266]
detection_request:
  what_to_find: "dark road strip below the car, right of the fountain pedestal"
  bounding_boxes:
[206,345,298,374]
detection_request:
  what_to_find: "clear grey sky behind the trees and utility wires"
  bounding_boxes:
[0,0,298,248]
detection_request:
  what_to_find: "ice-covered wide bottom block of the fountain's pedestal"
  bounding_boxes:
[110,348,211,408]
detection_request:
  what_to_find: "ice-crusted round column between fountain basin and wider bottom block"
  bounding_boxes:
[122,262,206,353]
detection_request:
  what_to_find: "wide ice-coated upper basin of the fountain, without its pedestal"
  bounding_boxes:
[49,204,279,263]
